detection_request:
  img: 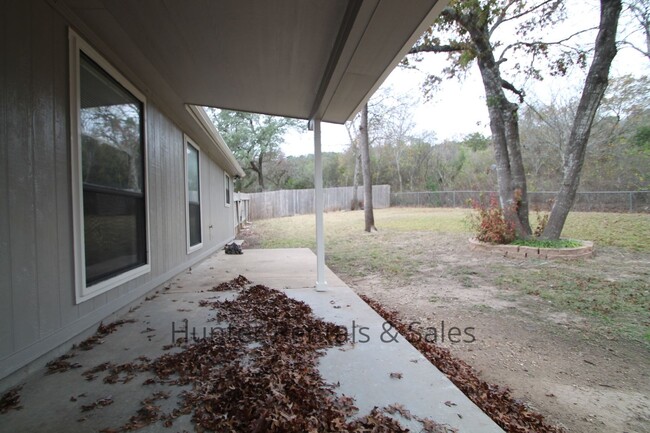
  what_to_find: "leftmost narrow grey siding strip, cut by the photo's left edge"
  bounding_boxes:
[0,2,14,359]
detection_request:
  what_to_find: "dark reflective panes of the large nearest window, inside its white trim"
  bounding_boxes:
[79,53,147,286]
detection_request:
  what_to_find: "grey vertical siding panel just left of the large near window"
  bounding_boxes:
[32,2,61,337]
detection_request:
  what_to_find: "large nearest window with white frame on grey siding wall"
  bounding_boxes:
[71,33,150,301]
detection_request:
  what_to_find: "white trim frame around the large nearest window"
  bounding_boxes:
[68,29,151,304]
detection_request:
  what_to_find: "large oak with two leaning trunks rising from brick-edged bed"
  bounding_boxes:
[406,0,621,238]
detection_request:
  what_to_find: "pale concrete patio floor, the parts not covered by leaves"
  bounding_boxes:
[0,249,502,433]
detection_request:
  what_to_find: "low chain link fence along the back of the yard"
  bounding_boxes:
[391,191,650,213]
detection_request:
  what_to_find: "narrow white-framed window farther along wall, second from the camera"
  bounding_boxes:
[185,138,203,253]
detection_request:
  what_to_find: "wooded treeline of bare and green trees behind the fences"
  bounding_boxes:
[219,76,650,192]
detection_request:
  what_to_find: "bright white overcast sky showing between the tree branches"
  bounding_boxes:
[282,0,650,156]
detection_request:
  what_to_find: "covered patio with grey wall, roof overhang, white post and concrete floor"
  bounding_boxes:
[0,0,501,432]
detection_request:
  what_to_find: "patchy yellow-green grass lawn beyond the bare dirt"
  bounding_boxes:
[249,208,650,344]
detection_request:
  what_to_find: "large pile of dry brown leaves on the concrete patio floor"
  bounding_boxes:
[91,276,450,433]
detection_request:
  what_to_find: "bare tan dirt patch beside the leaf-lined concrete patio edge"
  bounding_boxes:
[340,234,650,433]
